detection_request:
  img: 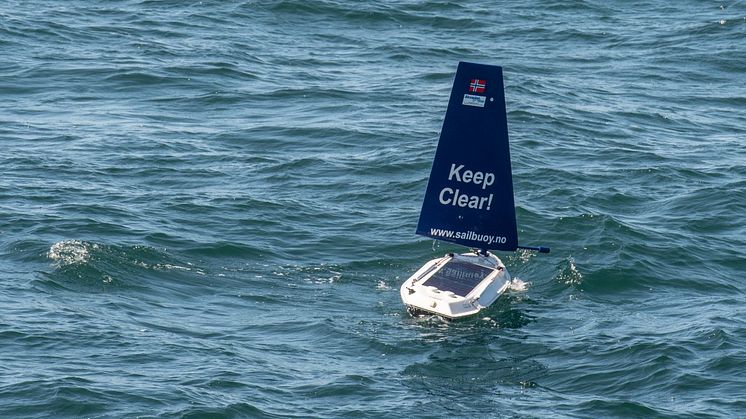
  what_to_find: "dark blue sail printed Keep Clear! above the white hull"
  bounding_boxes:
[417,62,518,251]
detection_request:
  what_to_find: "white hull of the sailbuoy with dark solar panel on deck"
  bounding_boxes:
[400,253,511,319]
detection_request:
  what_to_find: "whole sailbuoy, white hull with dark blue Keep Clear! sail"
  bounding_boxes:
[400,62,549,319]
